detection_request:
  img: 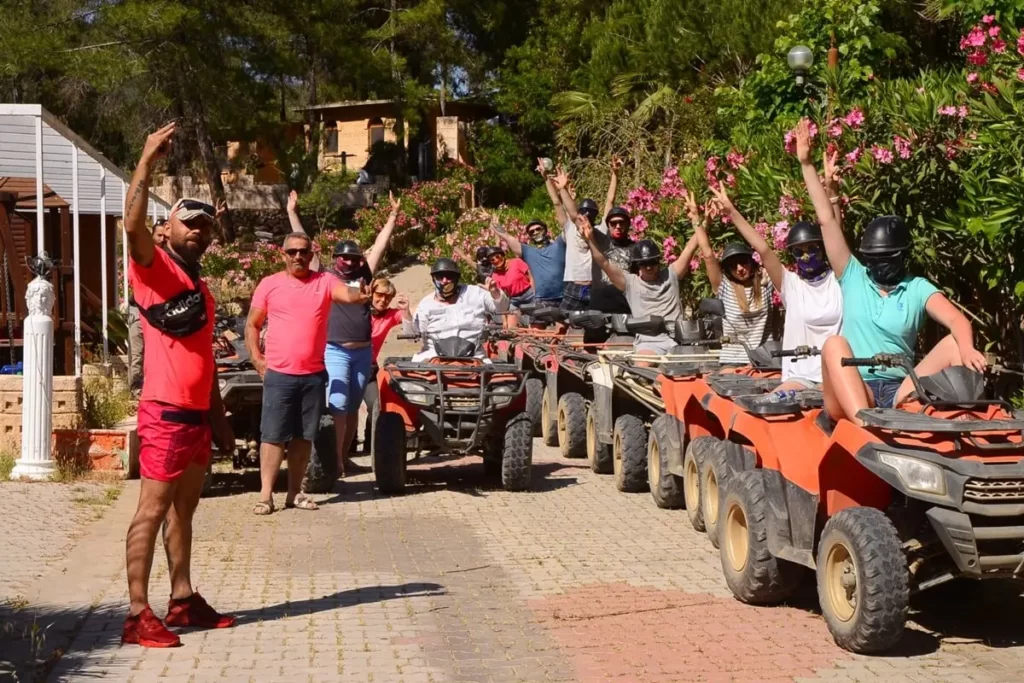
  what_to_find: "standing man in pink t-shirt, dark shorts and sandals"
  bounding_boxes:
[246,232,370,515]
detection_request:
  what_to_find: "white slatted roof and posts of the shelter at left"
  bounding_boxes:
[0,103,171,377]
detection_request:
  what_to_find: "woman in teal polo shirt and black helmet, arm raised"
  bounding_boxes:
[797,120,985,424]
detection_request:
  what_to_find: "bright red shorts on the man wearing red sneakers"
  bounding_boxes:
[138,400,213,481]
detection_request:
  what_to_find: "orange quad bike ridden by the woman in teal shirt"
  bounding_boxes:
[718,354,1024,653]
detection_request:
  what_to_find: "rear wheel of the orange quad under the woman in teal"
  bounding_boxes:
[719,470,803,605]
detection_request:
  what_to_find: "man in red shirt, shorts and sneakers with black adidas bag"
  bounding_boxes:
[122,123,234,647]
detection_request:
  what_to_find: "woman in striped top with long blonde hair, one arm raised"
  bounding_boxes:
[686,194,771,366]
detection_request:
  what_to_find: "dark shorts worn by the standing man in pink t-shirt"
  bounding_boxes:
[260,370,327,443]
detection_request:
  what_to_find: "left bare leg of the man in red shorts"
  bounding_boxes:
[125,479,177,616]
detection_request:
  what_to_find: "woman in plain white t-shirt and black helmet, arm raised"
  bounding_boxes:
[712,187,843,390]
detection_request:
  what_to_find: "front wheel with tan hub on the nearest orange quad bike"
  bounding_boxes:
[817,508,910,654]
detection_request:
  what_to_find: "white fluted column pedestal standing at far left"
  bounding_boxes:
[10,276,56,479]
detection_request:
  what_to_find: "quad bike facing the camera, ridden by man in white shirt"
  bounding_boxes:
[371,329,534,494]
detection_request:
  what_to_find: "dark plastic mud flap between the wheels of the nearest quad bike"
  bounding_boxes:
[762,470,818,569]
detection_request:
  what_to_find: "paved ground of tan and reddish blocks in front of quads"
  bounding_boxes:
[0,440,1024,683]
